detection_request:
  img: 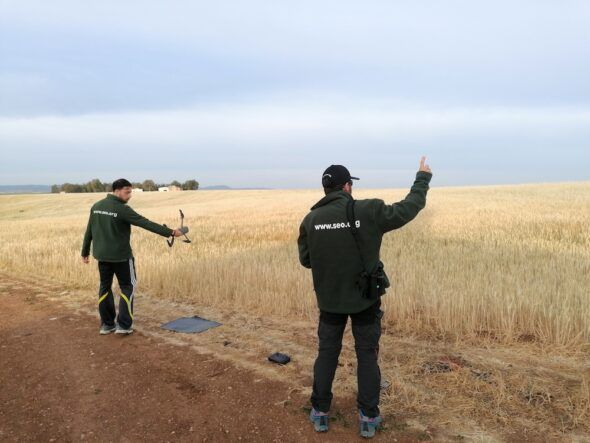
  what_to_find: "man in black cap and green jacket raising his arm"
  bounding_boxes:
[297,157,432,438]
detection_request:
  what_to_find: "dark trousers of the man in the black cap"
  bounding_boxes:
[311,300,383,417]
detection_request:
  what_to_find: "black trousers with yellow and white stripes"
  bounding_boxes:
[98,257,137,329]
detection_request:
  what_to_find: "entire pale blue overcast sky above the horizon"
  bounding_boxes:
[0,0,590,188]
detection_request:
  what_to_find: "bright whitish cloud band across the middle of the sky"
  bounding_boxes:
[0,96,590,145]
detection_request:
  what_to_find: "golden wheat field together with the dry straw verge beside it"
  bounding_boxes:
[0,183,590,441]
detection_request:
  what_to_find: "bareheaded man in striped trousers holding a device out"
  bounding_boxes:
[82,178,182,335]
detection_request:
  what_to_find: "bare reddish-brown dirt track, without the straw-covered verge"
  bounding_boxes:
[0,275,426,442]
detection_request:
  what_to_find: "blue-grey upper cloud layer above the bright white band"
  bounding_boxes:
[0,0,590,115]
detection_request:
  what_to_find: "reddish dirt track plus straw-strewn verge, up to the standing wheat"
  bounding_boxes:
[0,272,590,443]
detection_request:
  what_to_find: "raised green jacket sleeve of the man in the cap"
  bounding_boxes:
[375,171,432,233]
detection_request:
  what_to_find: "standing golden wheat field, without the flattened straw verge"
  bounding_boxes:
[0,183,590,348]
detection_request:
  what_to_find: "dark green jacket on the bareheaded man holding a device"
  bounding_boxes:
[82,194,173,262]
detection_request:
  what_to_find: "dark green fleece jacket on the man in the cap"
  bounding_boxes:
[297,172,432,314]
